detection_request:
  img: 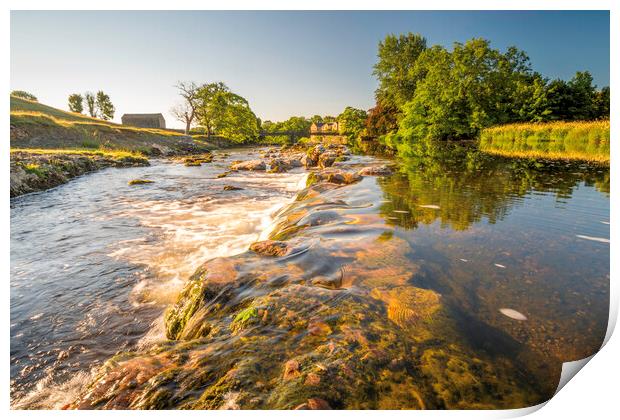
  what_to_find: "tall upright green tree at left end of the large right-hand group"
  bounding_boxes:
[373,32,427,108]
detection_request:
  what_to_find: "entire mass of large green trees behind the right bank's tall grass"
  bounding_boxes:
[360,33,610,146]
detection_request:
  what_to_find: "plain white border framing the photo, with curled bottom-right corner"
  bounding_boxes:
[0,0,620,419]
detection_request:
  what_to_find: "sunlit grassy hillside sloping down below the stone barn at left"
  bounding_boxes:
[11,96,211,155]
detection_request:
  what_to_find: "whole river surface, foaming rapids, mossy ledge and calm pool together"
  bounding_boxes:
[11,147,609,408]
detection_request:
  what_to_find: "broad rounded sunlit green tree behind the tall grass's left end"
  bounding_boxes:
[399,39,536,141]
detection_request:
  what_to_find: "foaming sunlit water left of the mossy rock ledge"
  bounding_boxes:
[11,150,305,405]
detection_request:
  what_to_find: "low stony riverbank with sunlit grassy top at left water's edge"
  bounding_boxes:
[10,149,149,197]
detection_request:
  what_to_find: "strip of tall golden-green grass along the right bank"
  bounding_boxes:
[480,121,609,163]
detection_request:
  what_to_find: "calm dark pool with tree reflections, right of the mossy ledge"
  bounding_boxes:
[378,144,610,363]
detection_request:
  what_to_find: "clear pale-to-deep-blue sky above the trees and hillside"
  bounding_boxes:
[11,11,609,127]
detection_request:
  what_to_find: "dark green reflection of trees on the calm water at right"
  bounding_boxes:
[380,143,610,230]
